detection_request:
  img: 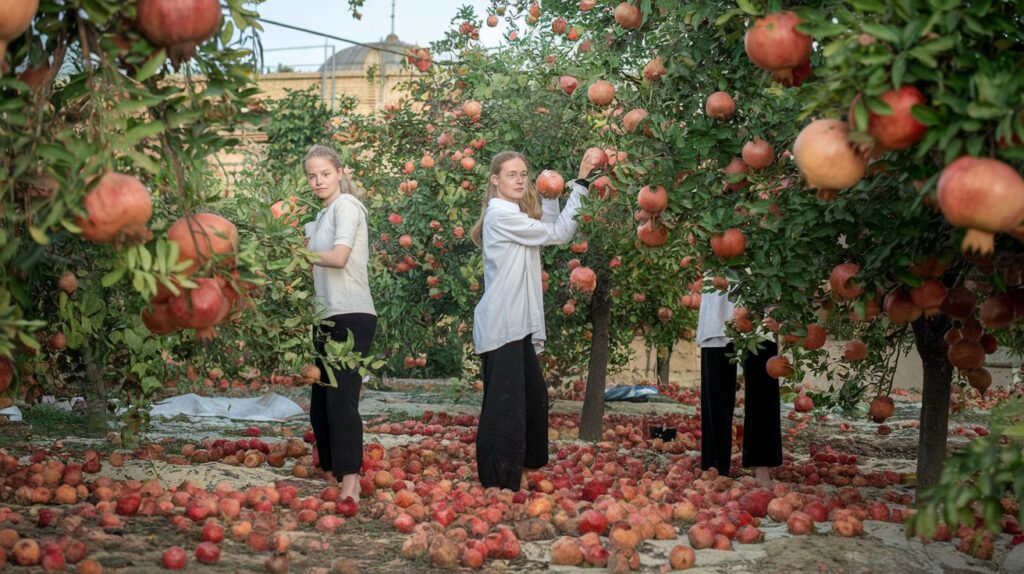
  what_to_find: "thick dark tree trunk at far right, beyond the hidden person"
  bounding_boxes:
[911,314,953,488]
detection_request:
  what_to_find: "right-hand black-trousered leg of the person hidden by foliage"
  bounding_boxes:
[742,341,782,476]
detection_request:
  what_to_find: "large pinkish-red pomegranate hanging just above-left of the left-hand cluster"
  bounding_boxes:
[75,172,153,244]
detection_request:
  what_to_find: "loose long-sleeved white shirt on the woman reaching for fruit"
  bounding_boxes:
[473,182,587,355]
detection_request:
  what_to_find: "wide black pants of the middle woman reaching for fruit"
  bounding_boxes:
[476,337,548,490]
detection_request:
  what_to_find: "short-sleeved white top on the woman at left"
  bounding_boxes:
[305,193,377,318]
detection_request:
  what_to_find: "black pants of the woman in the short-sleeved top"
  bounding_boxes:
[309,313,377,480]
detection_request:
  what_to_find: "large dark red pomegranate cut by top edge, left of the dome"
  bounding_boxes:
[135,0,221,68]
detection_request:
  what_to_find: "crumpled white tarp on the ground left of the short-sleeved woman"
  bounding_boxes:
[150,393,306,421]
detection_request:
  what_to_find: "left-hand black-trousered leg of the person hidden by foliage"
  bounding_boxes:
[700,343,736,475]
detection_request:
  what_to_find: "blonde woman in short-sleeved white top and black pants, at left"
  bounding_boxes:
[302,145,377,500]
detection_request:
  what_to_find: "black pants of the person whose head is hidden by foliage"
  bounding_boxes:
[700,341,782,475]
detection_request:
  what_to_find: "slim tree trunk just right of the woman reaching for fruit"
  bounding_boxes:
[580,271,611,441]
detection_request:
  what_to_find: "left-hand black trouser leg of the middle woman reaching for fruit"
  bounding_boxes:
[476,338,528,490]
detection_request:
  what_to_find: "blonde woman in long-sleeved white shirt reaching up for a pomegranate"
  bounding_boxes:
[470,151,596,491]
